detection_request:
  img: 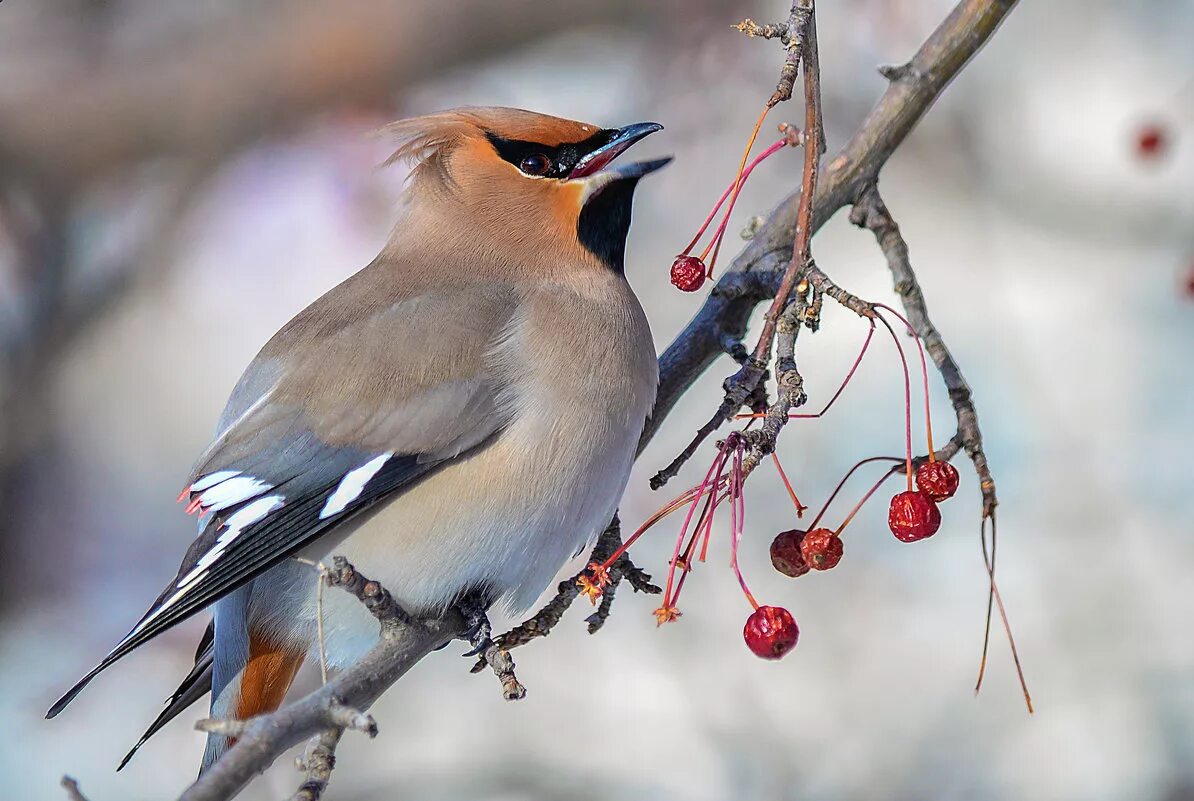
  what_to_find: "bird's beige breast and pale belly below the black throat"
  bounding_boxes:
[303,276,658,661]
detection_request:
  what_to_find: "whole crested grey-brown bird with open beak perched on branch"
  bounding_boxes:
[47,107,671,771]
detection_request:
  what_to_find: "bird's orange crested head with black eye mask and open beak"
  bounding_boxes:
[387,107,671,271]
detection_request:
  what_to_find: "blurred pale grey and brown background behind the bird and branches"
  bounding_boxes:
[0,0,1194,801]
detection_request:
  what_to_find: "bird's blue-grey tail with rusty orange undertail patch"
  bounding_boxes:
[199,583,307,774]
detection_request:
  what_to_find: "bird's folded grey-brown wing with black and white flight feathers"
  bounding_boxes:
[48,279,518,716]
